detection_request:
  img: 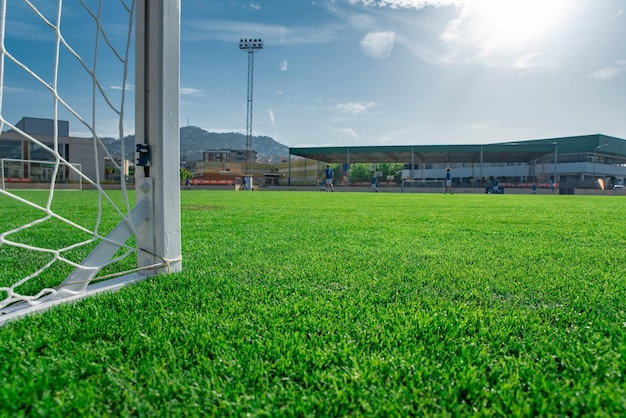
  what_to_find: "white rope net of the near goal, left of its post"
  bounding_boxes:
[0,0,137,310]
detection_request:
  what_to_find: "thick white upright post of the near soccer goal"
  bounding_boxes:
[135,0,182,280]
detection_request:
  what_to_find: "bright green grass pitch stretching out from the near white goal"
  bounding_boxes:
[0,191,626,417]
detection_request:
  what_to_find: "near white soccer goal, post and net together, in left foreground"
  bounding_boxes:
[0,0,182,325]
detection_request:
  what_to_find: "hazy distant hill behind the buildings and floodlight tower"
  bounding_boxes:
[102,126,289,163]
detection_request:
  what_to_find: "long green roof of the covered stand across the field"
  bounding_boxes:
[289,134,626,164]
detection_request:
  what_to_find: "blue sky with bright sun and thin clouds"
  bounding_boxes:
[3,0,626,147]
